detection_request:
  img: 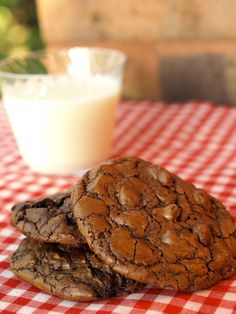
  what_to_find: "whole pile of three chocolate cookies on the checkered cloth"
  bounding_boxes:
[11,157,236,301]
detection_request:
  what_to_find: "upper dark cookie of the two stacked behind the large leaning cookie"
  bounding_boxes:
[11,192,84,246]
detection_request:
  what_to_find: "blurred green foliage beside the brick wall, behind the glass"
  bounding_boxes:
[0,0,44,59]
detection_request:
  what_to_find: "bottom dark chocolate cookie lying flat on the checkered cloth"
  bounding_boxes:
[11,238,143,302]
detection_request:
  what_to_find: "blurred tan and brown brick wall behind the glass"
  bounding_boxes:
[37,0,236,103]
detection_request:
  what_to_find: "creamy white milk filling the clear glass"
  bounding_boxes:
[3,77,120,174]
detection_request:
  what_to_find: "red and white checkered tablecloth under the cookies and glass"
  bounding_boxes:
[0,102,236,314]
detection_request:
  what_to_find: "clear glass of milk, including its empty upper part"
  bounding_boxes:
[0,48,126,174]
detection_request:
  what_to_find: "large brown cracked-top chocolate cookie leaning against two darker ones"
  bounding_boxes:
[72,158,236,292]
